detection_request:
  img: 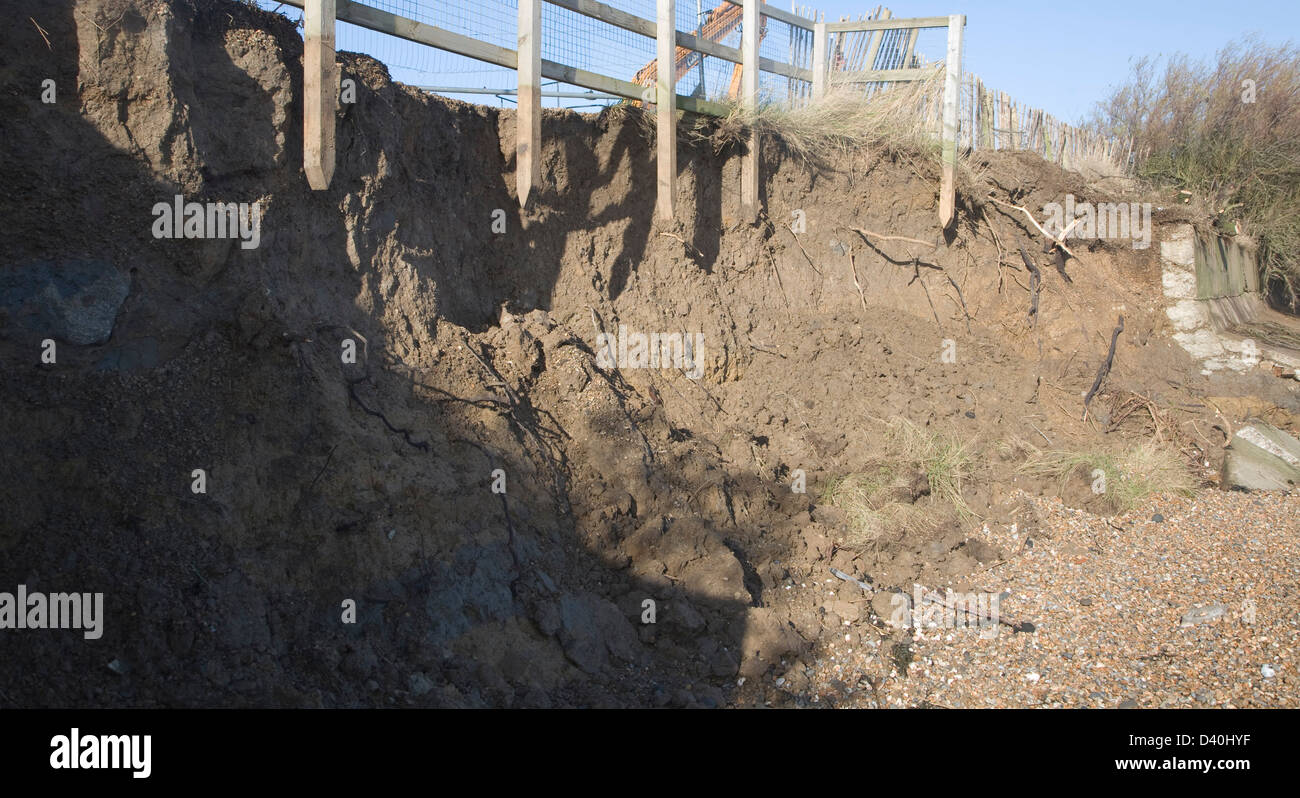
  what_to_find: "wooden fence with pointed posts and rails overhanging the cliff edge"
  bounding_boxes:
[285,0,966,226]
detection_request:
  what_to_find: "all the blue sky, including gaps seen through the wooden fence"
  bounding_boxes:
[260,0,1300,122]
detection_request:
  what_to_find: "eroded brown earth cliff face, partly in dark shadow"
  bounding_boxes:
[0,0,1300,707]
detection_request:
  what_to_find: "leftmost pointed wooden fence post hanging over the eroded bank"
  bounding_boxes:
[303,0,338,191]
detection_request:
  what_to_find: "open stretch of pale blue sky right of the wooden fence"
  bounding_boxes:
[821,0,1300,122]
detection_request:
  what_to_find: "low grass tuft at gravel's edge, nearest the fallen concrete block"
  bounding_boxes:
[1015,439,1196,513]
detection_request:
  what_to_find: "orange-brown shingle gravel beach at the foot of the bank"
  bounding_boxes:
[810,491,1300,708]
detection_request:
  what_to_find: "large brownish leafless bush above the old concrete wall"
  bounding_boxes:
[1091,38,1300,311]
